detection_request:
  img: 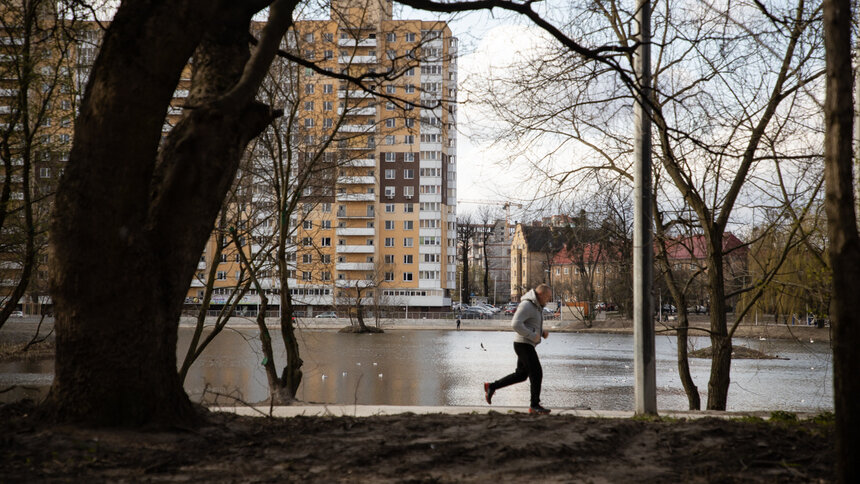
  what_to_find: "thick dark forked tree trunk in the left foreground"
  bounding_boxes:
[43,0,288,426]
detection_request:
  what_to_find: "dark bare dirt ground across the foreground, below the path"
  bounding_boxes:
[0,402,834,483]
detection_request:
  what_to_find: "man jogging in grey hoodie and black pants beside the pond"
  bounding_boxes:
[484,284,552,414]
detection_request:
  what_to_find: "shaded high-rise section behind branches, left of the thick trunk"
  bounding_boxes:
[0,2,86,314]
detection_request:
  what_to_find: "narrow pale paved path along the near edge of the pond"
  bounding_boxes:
[210,404,788,419]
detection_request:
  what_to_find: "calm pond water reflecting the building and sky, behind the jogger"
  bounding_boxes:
[0,328,833,412]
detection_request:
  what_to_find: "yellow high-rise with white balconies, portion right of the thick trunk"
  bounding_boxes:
[187,0,457,314]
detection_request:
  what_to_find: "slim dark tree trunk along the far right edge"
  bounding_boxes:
[824,0,860,483]
